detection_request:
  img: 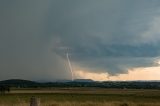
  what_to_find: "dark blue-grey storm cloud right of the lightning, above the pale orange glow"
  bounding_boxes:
[52,0,160,74]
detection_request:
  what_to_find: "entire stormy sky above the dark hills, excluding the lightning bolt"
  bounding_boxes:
[0,0,160,81]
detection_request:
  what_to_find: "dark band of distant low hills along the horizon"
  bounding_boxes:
[0,79,160,89]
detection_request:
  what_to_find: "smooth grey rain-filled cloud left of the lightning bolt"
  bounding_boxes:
[0,0,70,80]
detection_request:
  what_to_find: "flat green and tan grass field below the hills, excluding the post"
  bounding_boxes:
[0,88,160,106]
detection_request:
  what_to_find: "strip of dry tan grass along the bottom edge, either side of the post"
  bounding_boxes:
[0,101,160,106]
